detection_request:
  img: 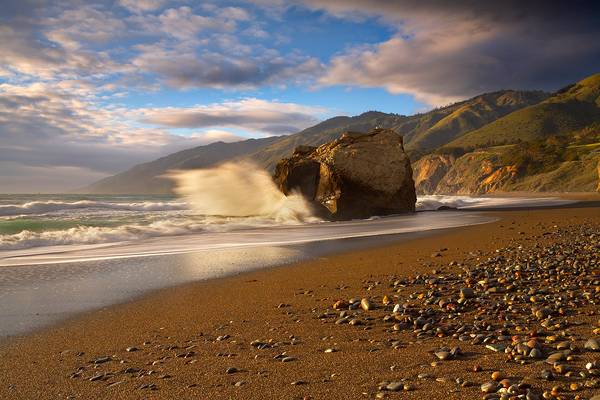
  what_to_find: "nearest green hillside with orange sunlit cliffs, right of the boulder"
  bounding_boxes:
[414,74,600,194]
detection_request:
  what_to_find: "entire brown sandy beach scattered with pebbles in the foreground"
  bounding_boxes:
[0,205,600,399]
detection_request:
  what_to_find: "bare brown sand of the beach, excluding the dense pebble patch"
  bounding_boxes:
[0,206,598,399]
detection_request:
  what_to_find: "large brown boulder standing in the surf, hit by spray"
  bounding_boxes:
[274,129,416,220]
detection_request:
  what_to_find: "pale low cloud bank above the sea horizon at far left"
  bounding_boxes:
[0,82,252,191]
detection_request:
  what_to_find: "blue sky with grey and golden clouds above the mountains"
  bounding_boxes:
[0,0,600,193]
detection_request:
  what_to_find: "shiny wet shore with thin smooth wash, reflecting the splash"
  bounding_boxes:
[0,211,491,340]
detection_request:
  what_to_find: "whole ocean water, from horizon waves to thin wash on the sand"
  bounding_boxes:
[0,193,576,337]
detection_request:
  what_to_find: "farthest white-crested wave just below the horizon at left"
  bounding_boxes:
[0,200,188,216]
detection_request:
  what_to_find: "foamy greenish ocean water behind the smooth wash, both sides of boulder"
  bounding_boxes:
[0,194,576,251]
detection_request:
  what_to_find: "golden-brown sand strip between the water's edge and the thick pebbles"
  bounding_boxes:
[0,207,600,399]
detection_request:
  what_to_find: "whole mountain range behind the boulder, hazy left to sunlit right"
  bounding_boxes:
[83,73,600,194]
